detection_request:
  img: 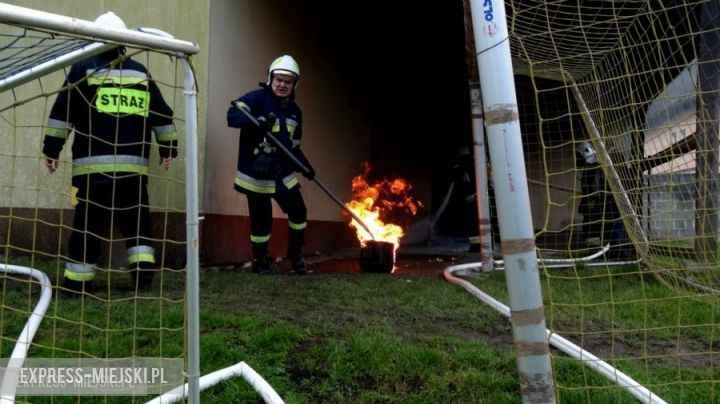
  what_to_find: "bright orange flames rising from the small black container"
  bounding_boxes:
[345,162,422,249]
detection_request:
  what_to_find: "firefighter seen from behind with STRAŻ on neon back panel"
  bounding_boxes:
[42,13,177,294]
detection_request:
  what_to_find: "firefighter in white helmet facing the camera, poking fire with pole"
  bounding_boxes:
[227,55,315,274]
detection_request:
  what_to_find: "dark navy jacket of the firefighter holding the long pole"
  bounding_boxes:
[227,84,310,194]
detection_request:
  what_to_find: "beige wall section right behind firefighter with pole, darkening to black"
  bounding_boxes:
[203,0,370,221]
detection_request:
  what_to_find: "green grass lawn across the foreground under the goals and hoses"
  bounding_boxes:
[0,263,720,403]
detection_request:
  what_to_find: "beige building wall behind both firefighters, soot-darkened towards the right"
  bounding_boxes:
[0,0,371,261]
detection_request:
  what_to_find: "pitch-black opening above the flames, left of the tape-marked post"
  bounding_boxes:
[301,1,472,235]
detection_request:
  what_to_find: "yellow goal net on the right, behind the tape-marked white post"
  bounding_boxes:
[478,0,720,402]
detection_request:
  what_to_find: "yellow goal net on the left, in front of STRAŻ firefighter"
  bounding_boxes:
[0,4,198,398]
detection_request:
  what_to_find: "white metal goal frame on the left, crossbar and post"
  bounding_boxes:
[0,3,200,403]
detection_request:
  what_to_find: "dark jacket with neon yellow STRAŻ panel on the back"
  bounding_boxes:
[43,50,177,186]
